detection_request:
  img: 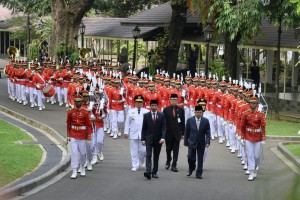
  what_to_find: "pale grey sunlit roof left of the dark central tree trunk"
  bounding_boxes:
[83,17,156,39]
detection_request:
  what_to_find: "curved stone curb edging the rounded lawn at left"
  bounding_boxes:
[0,105,71,199]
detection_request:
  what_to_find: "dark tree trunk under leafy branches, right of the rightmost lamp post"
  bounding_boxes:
[224,33,241,79]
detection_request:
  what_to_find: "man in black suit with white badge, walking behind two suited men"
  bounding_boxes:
[163,94,185,172]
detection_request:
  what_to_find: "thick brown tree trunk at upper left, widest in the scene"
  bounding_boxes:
[49,0,94,58]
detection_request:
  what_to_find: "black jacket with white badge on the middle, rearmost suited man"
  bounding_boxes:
[163,106,185,141]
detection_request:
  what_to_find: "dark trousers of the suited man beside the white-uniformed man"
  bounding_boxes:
[146,142,161,174]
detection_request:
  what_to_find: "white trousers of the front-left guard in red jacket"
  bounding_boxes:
[71,138,87,169]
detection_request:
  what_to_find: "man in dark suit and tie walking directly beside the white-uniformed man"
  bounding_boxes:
[141,100,166,179]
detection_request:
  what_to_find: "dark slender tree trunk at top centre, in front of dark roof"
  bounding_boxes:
[165,0,187,74]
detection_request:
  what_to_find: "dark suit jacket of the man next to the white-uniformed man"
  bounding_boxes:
[141,112,166,145]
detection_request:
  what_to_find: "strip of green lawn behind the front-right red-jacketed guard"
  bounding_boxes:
[266,118,300,137]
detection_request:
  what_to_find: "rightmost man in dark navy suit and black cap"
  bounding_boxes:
[184,106,210,179]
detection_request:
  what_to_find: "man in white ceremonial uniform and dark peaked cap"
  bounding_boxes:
[124,95,149,172]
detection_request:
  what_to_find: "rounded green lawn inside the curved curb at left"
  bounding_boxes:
[0,120,42,187]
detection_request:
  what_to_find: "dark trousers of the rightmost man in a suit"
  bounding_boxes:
[188,147,205,176]
